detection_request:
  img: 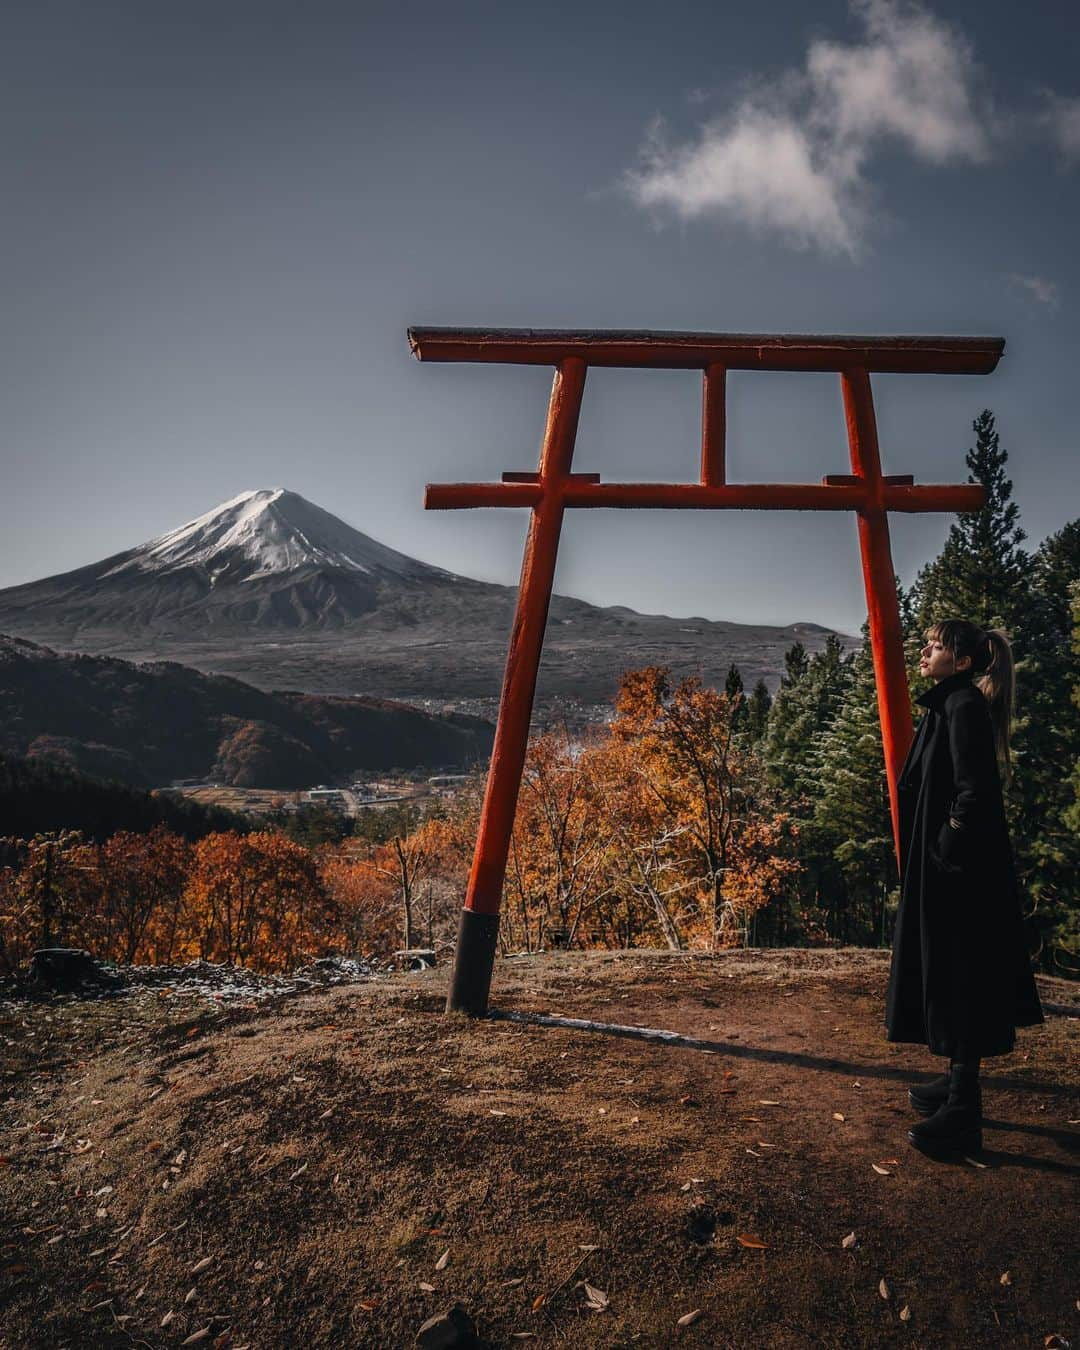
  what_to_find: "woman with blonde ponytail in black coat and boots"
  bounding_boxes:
[886,618,1044,1157]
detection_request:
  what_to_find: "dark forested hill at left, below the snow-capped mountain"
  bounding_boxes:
[0,636,494,788]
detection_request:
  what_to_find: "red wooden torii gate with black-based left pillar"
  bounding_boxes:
[408,328,1004,1015]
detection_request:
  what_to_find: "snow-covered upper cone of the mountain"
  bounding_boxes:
[97,487,448,586]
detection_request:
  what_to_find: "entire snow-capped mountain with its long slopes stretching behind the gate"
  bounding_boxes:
[0,489,856,702]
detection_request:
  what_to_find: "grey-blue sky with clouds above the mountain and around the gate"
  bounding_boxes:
[0,0,1080,633]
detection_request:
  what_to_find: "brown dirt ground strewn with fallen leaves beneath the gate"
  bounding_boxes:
[0,950,1080,1350]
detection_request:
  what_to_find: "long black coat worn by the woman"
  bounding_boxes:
[886,671,1044,1056]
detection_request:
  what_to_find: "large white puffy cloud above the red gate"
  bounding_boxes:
[624,0,991,257]
